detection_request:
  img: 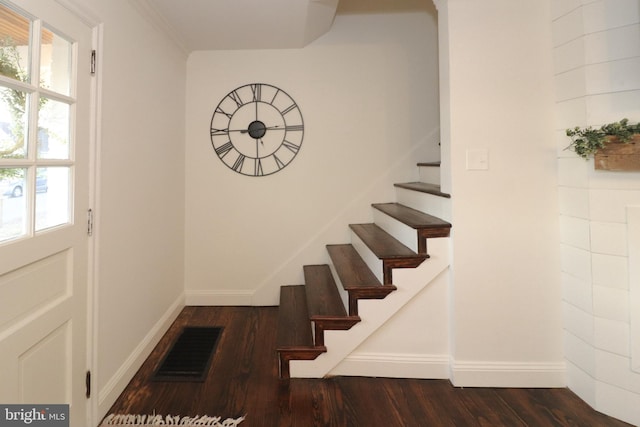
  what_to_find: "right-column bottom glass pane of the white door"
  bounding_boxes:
[35,167,71,231]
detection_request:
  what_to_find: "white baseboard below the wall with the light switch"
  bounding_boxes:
[451,361,567,388]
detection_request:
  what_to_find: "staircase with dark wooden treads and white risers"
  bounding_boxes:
[276,163,451,379]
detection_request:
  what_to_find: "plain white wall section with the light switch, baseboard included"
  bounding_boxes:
[437,0,564,386]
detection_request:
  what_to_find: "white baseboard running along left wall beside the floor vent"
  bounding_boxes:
[98,294,185,419]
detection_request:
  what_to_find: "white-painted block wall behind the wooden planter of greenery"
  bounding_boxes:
[552,0,640,425]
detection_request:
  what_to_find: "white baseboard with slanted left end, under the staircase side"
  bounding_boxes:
[329,353,449,379]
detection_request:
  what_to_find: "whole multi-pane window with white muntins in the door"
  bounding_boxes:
[0,0,75,244]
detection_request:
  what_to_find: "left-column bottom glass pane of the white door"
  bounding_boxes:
[0,168,28,243]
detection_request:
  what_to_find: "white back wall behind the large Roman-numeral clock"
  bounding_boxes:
[185,6,439,305]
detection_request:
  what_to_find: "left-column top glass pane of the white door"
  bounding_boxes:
[0,4,31,82]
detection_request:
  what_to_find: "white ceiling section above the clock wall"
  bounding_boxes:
[130,0,338,53]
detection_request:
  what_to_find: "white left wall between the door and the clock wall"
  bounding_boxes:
[78,0,186,422]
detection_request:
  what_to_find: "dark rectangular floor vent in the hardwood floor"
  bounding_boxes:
[153,326,222,381]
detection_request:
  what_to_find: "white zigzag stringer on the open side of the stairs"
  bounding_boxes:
[290,238,449,378]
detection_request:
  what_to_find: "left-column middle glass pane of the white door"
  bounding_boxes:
[0,86,29,159]
